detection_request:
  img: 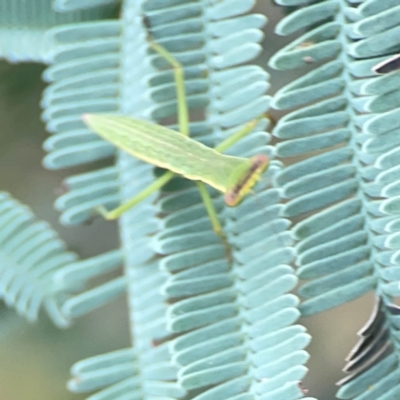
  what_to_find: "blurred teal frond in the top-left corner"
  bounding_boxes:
[0,0,113,63]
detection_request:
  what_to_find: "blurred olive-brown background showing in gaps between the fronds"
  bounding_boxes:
[0,2,373,400]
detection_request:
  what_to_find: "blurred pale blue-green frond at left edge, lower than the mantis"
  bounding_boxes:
[0,192,126,328]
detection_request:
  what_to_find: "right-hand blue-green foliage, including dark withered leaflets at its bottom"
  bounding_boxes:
[271,0,400,400]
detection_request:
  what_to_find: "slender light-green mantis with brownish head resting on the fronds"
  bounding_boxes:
[83,43,269,244]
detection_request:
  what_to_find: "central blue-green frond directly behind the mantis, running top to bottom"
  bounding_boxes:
[144,1,309,400]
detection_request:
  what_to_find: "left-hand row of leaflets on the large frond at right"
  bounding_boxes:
[271,0,400,315]
